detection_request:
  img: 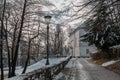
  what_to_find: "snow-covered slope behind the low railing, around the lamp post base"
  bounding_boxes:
[6,57,68,80]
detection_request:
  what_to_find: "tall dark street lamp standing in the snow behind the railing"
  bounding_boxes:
[44,16,51,65]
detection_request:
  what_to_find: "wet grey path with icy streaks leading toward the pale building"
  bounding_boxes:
[74,58,120,80]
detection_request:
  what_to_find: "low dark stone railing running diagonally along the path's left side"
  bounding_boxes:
[7,57,71,80]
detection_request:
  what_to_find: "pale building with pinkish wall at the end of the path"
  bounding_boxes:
[69,25,96,57]
